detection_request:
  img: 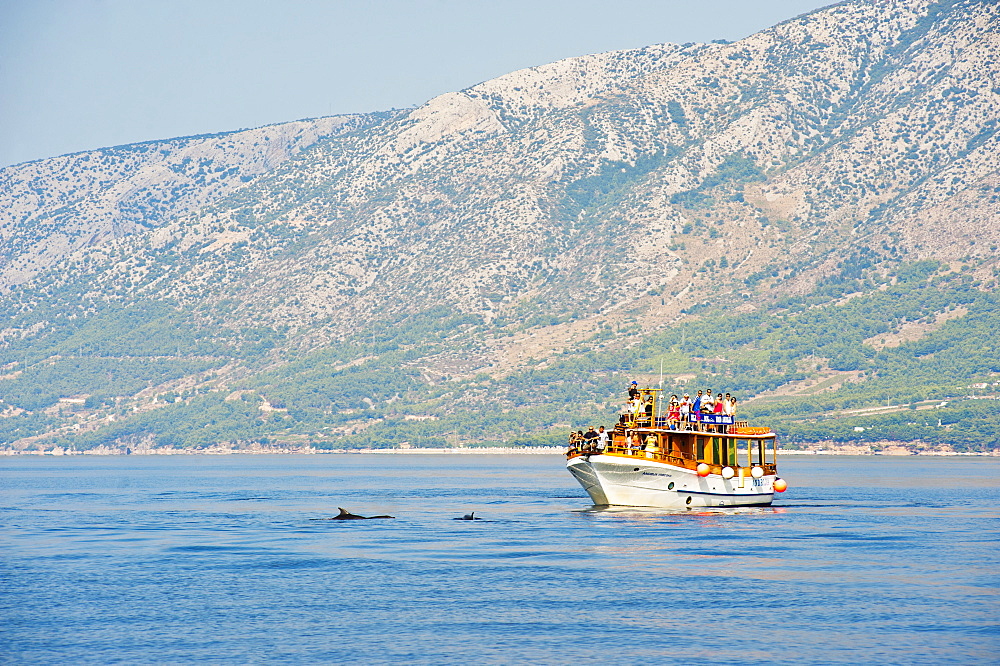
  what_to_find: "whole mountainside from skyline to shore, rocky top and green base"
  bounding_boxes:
[0,0,1000,448]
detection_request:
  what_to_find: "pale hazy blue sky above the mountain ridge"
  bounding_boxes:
[0,0,830,166]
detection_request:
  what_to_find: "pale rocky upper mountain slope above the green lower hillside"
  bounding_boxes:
[0,0,1000,452]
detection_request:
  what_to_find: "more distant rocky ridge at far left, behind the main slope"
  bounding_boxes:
[0,116,378,291]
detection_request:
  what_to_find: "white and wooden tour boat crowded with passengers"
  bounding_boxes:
[566,388,788,509]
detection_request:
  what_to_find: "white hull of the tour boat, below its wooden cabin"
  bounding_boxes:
[566,454,776,509]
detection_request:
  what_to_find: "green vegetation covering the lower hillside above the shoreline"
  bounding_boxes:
[0,259,1000,450]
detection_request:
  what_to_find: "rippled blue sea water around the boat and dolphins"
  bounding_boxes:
[0,455,1000,664]
